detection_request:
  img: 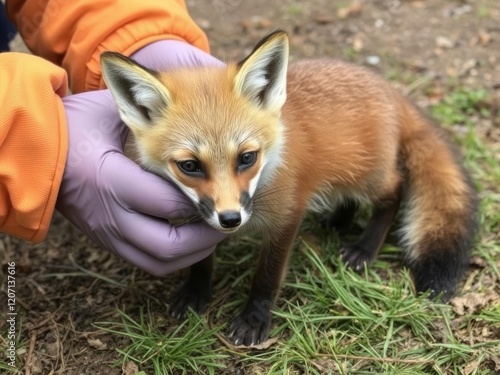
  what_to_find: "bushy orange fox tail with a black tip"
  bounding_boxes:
[400,103,478,301]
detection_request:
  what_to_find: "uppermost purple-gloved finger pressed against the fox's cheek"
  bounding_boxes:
[101,153,197,219]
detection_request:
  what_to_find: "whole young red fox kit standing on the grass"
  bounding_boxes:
[101,31,477,346]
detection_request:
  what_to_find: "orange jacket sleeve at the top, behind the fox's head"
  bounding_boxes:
[6,0,208,93]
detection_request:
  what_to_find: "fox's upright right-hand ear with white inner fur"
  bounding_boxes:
[235,30,288,110]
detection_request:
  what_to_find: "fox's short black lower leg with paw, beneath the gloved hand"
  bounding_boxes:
[170,253,214,319]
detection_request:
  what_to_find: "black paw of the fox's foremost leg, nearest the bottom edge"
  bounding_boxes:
[229,311,271,346]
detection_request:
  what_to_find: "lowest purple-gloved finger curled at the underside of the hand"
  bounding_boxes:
[117,242,215,277]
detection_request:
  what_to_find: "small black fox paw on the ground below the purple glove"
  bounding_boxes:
[170,284,212,319]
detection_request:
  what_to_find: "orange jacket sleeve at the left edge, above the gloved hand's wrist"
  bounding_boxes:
[0,53,68,242]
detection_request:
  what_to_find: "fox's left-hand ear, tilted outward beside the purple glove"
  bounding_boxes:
[101,52,171,130]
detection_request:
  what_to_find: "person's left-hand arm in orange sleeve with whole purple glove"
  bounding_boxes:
[0,53,224,276]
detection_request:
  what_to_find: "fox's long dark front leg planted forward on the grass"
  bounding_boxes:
[230,214,302,346]
